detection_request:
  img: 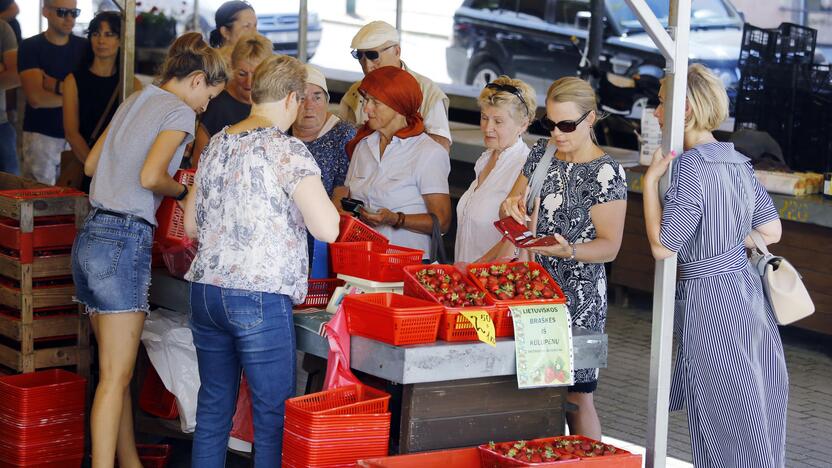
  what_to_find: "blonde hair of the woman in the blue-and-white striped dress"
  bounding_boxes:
[676,63,728,132]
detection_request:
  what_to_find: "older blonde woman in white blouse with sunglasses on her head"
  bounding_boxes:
[454,75,537,262]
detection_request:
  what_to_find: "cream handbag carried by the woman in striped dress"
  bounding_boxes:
[749,231,815,325]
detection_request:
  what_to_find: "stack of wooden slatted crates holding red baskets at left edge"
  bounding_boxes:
[0,184,89,376]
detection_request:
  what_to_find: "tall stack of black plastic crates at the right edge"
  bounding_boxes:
[734,23,832,171]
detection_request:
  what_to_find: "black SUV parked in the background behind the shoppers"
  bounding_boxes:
[446,0,743,107]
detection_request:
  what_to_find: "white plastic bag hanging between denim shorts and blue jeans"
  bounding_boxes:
[142,309,199,432]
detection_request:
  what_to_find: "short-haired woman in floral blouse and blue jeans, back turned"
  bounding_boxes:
[185,55,339,468]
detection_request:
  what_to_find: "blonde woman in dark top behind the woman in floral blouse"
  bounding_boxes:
[191,32,274,167]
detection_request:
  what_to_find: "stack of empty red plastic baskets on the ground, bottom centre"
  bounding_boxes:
[283,385,390,468]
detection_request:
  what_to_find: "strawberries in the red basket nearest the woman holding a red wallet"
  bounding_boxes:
[471,263,559,300]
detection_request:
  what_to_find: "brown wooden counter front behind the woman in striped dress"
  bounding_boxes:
[610,166,832,335]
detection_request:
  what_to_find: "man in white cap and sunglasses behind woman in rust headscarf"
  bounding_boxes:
[338,21,451,150]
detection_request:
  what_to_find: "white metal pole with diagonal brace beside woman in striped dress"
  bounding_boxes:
[626,0,691,468]
